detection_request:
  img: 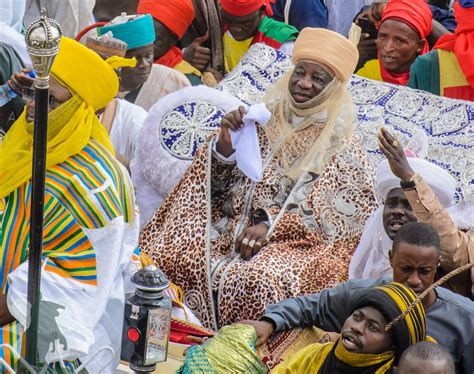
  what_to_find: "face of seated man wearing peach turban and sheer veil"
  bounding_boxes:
[288,62,334,103]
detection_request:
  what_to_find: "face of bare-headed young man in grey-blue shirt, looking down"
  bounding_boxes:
[390,242,439,295]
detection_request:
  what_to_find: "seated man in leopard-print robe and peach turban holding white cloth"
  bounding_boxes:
[140,28,374,329]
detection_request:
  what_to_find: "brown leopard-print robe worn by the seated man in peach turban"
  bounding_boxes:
[140,122,375,329]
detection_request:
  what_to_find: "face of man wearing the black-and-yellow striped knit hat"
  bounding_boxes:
[341,306,393,354]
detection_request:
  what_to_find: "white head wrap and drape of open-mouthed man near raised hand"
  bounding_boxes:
[349,158,456,279]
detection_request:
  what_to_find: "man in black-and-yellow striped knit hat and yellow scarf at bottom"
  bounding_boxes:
[272,283,428,374]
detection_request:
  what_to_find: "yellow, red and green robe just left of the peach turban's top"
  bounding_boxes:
[223,17,299,73]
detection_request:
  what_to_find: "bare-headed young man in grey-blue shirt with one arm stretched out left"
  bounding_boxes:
[244,222,474,374]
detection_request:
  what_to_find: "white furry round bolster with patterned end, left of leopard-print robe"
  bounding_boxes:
[130,86,244,229]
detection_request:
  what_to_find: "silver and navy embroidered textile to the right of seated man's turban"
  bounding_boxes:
[349,76,474,203]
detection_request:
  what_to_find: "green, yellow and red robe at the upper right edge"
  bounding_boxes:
[408,49,474,101]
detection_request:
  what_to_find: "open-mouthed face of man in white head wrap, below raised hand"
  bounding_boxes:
[382,188,417,240]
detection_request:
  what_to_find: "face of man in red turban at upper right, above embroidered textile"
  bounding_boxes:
[376,19,424,74]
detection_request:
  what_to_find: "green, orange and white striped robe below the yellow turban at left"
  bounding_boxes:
[0,141,138,373]
